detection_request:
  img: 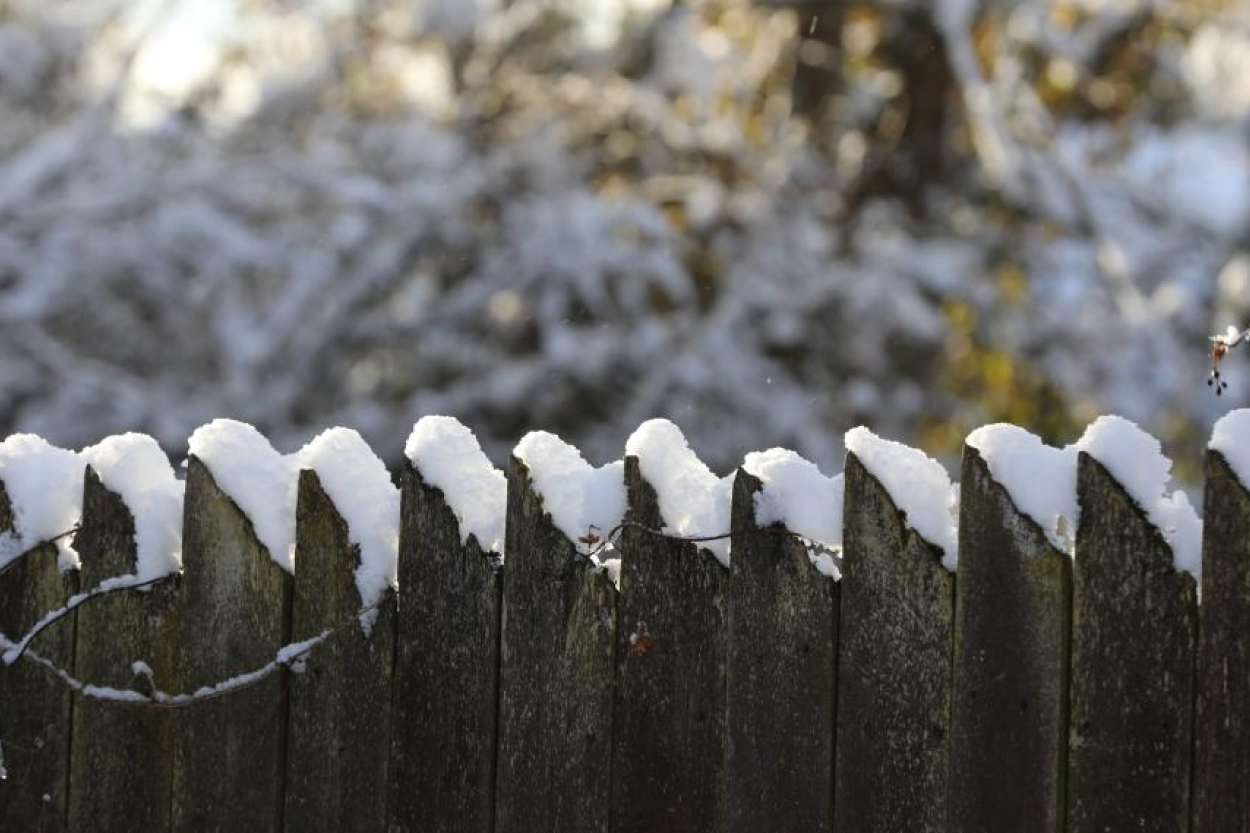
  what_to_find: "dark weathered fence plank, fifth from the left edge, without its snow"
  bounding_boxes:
[389,463,501,833]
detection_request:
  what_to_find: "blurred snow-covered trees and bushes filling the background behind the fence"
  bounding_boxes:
[0,0,1250,469]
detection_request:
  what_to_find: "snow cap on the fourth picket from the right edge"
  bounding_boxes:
[846,425,959,570]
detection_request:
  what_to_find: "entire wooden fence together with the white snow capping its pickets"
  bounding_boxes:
[0,411,1250,833]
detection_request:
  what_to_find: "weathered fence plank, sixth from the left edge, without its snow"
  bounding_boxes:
[495,458,616,833]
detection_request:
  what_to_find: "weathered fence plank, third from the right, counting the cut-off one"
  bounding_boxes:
[950,448,1071,833]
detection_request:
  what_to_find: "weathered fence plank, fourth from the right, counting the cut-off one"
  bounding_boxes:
[834,453,955,833]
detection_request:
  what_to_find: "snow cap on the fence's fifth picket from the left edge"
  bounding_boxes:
[404,417,508,555]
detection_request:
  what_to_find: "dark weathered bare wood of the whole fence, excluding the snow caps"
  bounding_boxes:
[0,440,1250,833]
